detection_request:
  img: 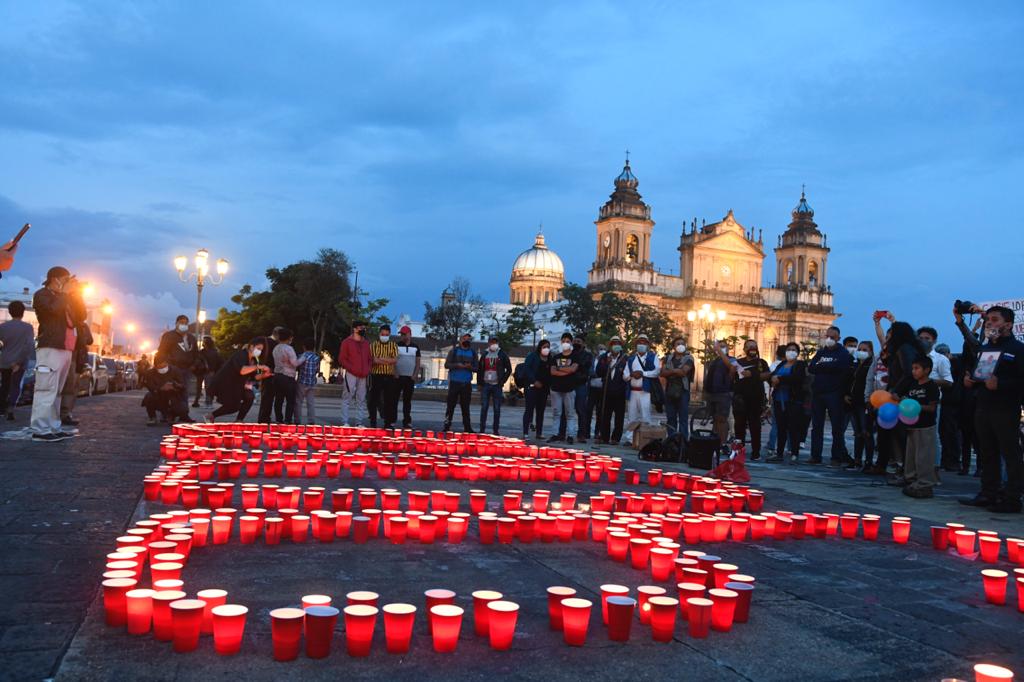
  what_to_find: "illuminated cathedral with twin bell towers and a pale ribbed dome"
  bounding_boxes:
[509,159,837,350]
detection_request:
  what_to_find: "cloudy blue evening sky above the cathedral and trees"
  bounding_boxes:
[0,0,1024,341]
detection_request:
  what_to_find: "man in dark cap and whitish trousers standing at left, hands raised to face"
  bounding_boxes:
[31,265,78,442]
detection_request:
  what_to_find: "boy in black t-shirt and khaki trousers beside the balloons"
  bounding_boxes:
[903,355,939,499]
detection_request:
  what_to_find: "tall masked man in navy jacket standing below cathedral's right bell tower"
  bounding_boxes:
[807,327,853,467]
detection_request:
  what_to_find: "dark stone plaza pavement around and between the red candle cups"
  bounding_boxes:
[0,393,1024,680]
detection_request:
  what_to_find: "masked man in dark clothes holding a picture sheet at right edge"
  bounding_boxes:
[961,305,1024,513]
